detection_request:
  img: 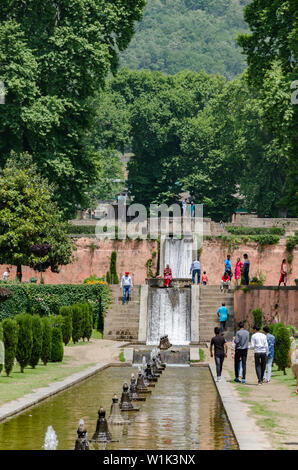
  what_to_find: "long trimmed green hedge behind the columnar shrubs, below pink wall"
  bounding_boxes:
[0,283,110,325]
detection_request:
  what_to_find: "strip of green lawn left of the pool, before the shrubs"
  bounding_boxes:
[0,356,94,405]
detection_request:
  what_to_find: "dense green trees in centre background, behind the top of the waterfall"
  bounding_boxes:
[97,69,290,220]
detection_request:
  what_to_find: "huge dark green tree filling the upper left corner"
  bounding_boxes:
[0,0,145,216]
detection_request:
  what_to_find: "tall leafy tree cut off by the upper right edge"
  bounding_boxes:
[238,0,298,216]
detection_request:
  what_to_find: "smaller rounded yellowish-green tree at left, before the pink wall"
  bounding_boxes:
[0,154,73,279]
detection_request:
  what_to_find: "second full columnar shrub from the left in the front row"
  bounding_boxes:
[16,313,33,373]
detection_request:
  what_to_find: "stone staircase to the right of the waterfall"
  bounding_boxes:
[199,285,234,342]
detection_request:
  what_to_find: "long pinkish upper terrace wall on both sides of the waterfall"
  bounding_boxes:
[0,238,298,286]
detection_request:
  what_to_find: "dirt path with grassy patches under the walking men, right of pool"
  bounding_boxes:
[204,343,298,450]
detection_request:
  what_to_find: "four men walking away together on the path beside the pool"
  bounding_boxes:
[210,322,275,385]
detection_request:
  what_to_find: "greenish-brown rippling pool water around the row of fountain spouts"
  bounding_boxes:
[0,367,237,450]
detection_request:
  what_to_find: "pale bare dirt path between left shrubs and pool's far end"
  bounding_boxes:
[64,339,127,365]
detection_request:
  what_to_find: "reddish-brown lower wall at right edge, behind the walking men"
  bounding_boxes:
[234,287,298,328]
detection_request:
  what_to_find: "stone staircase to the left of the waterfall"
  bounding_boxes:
[103,285,140,341]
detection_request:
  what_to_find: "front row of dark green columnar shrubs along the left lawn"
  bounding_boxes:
[0,313,64,376]
